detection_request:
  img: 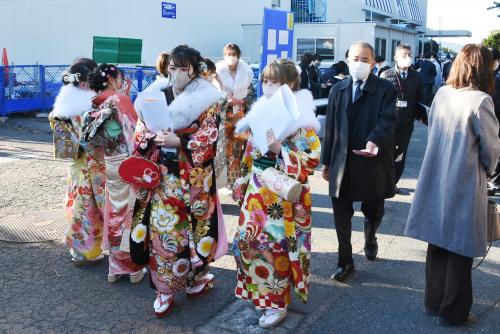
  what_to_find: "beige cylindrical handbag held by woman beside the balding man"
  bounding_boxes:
[261,151,302,203]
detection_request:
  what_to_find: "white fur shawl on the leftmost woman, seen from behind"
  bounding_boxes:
[52,84,95,118]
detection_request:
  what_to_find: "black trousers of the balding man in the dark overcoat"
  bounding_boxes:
[332,197,384,267]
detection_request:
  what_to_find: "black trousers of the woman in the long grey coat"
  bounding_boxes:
[425,244,473,325]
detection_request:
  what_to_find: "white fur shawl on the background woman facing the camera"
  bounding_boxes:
[215,59,253,100]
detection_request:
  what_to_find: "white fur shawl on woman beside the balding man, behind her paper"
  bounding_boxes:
[236,89,320,138]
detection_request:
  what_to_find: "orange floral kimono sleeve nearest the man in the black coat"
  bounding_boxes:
[281,129,321,183]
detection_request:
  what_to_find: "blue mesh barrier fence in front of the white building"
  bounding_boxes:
[0,65,259,117]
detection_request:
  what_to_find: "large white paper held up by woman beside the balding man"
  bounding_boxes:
[248,85,300,154]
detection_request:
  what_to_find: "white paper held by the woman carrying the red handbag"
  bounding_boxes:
[141,91,171,132]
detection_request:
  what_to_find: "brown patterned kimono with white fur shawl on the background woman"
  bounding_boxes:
[216,60,256,189]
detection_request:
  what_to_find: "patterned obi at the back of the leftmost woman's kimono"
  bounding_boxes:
[51,119,80,159]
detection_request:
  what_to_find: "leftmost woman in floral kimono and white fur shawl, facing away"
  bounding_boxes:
[49,58,105,265]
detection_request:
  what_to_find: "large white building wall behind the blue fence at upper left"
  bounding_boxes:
[0,0,272,65]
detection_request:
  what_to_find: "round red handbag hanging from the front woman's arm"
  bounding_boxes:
[118,136,161,189]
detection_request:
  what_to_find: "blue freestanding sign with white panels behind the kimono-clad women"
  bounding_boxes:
[260,8,293,96]
